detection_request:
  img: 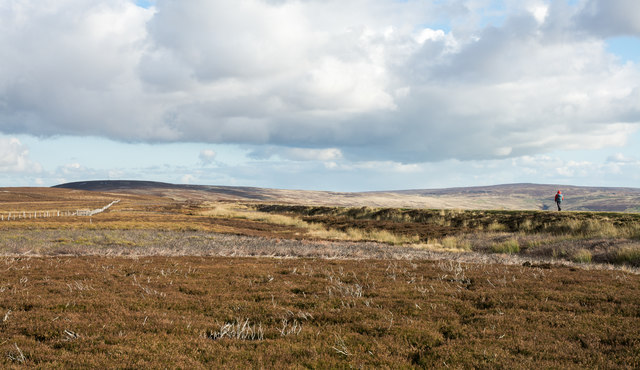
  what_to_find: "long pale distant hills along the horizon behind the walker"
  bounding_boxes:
[54,180,640,212]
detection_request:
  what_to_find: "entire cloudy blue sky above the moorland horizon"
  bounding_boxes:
[0,0,640,191]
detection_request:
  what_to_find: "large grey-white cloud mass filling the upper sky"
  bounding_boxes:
[0,0,640,165]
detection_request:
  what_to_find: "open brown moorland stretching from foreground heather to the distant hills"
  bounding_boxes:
[0,182,640,368]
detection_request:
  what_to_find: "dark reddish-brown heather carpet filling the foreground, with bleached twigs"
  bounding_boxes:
[0,256,640,368]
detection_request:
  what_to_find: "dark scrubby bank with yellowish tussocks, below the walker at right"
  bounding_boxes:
[246,205,640,267]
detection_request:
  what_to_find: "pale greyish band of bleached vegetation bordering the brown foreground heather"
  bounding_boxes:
[0,230,640,274]
